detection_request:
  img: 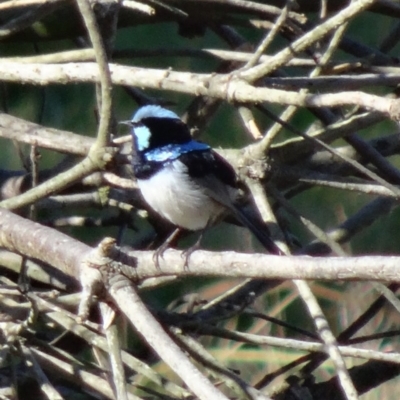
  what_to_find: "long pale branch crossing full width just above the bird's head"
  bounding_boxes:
[0,61,400,119]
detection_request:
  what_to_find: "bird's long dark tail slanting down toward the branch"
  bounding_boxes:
[234,206,284,255]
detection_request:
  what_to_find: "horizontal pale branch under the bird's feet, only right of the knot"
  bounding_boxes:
[121,249,400,282]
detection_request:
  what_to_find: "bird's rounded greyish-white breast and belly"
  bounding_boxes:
[138,160,225,230]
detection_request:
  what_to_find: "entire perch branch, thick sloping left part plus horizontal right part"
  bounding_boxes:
[0,208,400,288]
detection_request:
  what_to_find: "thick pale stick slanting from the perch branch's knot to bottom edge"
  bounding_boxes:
[108,275,228,400]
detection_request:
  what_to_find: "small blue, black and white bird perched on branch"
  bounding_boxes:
[123,105,282,262]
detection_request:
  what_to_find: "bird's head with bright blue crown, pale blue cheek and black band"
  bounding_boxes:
[124,105,192,152]
